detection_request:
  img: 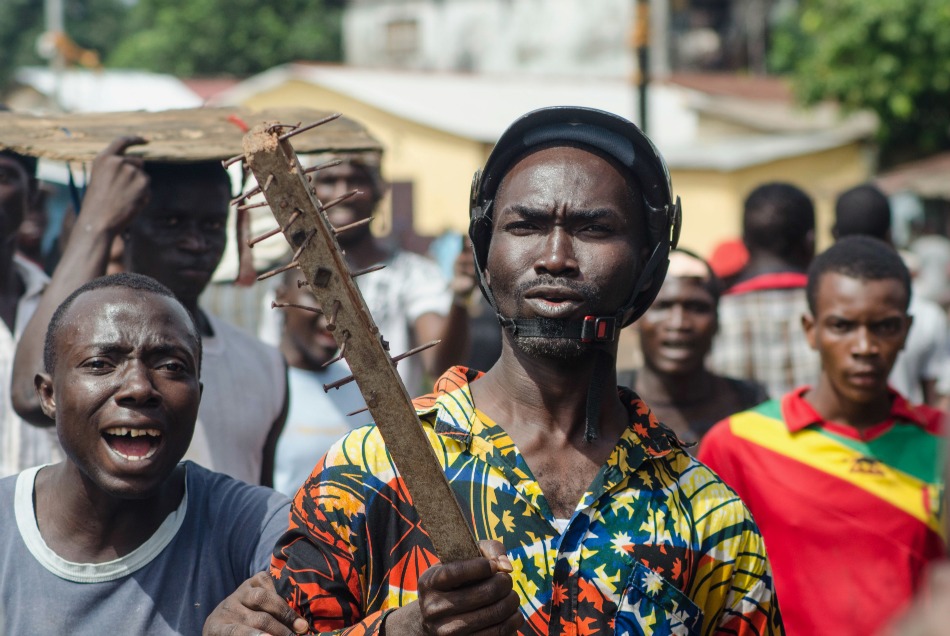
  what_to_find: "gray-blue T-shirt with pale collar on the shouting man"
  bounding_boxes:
[0,462,290,636]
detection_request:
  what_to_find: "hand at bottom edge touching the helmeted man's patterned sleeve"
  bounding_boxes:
[201,572,309,636]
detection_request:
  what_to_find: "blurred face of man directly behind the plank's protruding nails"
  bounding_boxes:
[313,162,381,246]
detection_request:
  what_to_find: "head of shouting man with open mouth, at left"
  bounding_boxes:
[37,287,201,499]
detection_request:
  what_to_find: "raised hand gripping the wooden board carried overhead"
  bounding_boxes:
[76,137,148,236]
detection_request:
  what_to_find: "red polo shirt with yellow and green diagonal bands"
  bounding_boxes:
[699,388,945,636]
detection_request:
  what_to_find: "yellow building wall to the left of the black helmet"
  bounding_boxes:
[243,80,490,236]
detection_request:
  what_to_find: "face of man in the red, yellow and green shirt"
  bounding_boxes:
[802,272,911,404]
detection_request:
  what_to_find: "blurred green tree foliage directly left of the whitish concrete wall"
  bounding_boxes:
[109,0,341,76]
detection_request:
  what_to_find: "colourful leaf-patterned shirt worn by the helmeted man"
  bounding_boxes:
[271,367,783,636]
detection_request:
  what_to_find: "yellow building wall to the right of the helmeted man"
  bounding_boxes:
[670,142,871,255]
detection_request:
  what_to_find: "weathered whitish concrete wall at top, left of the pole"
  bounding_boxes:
[343,0,635,77]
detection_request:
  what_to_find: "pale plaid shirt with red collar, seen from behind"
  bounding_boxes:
[709,274,821,395]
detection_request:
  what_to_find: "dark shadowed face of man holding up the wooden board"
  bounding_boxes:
[124,173,230,304]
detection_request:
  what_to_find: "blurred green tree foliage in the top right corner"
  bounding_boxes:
[771,0,950,163]
